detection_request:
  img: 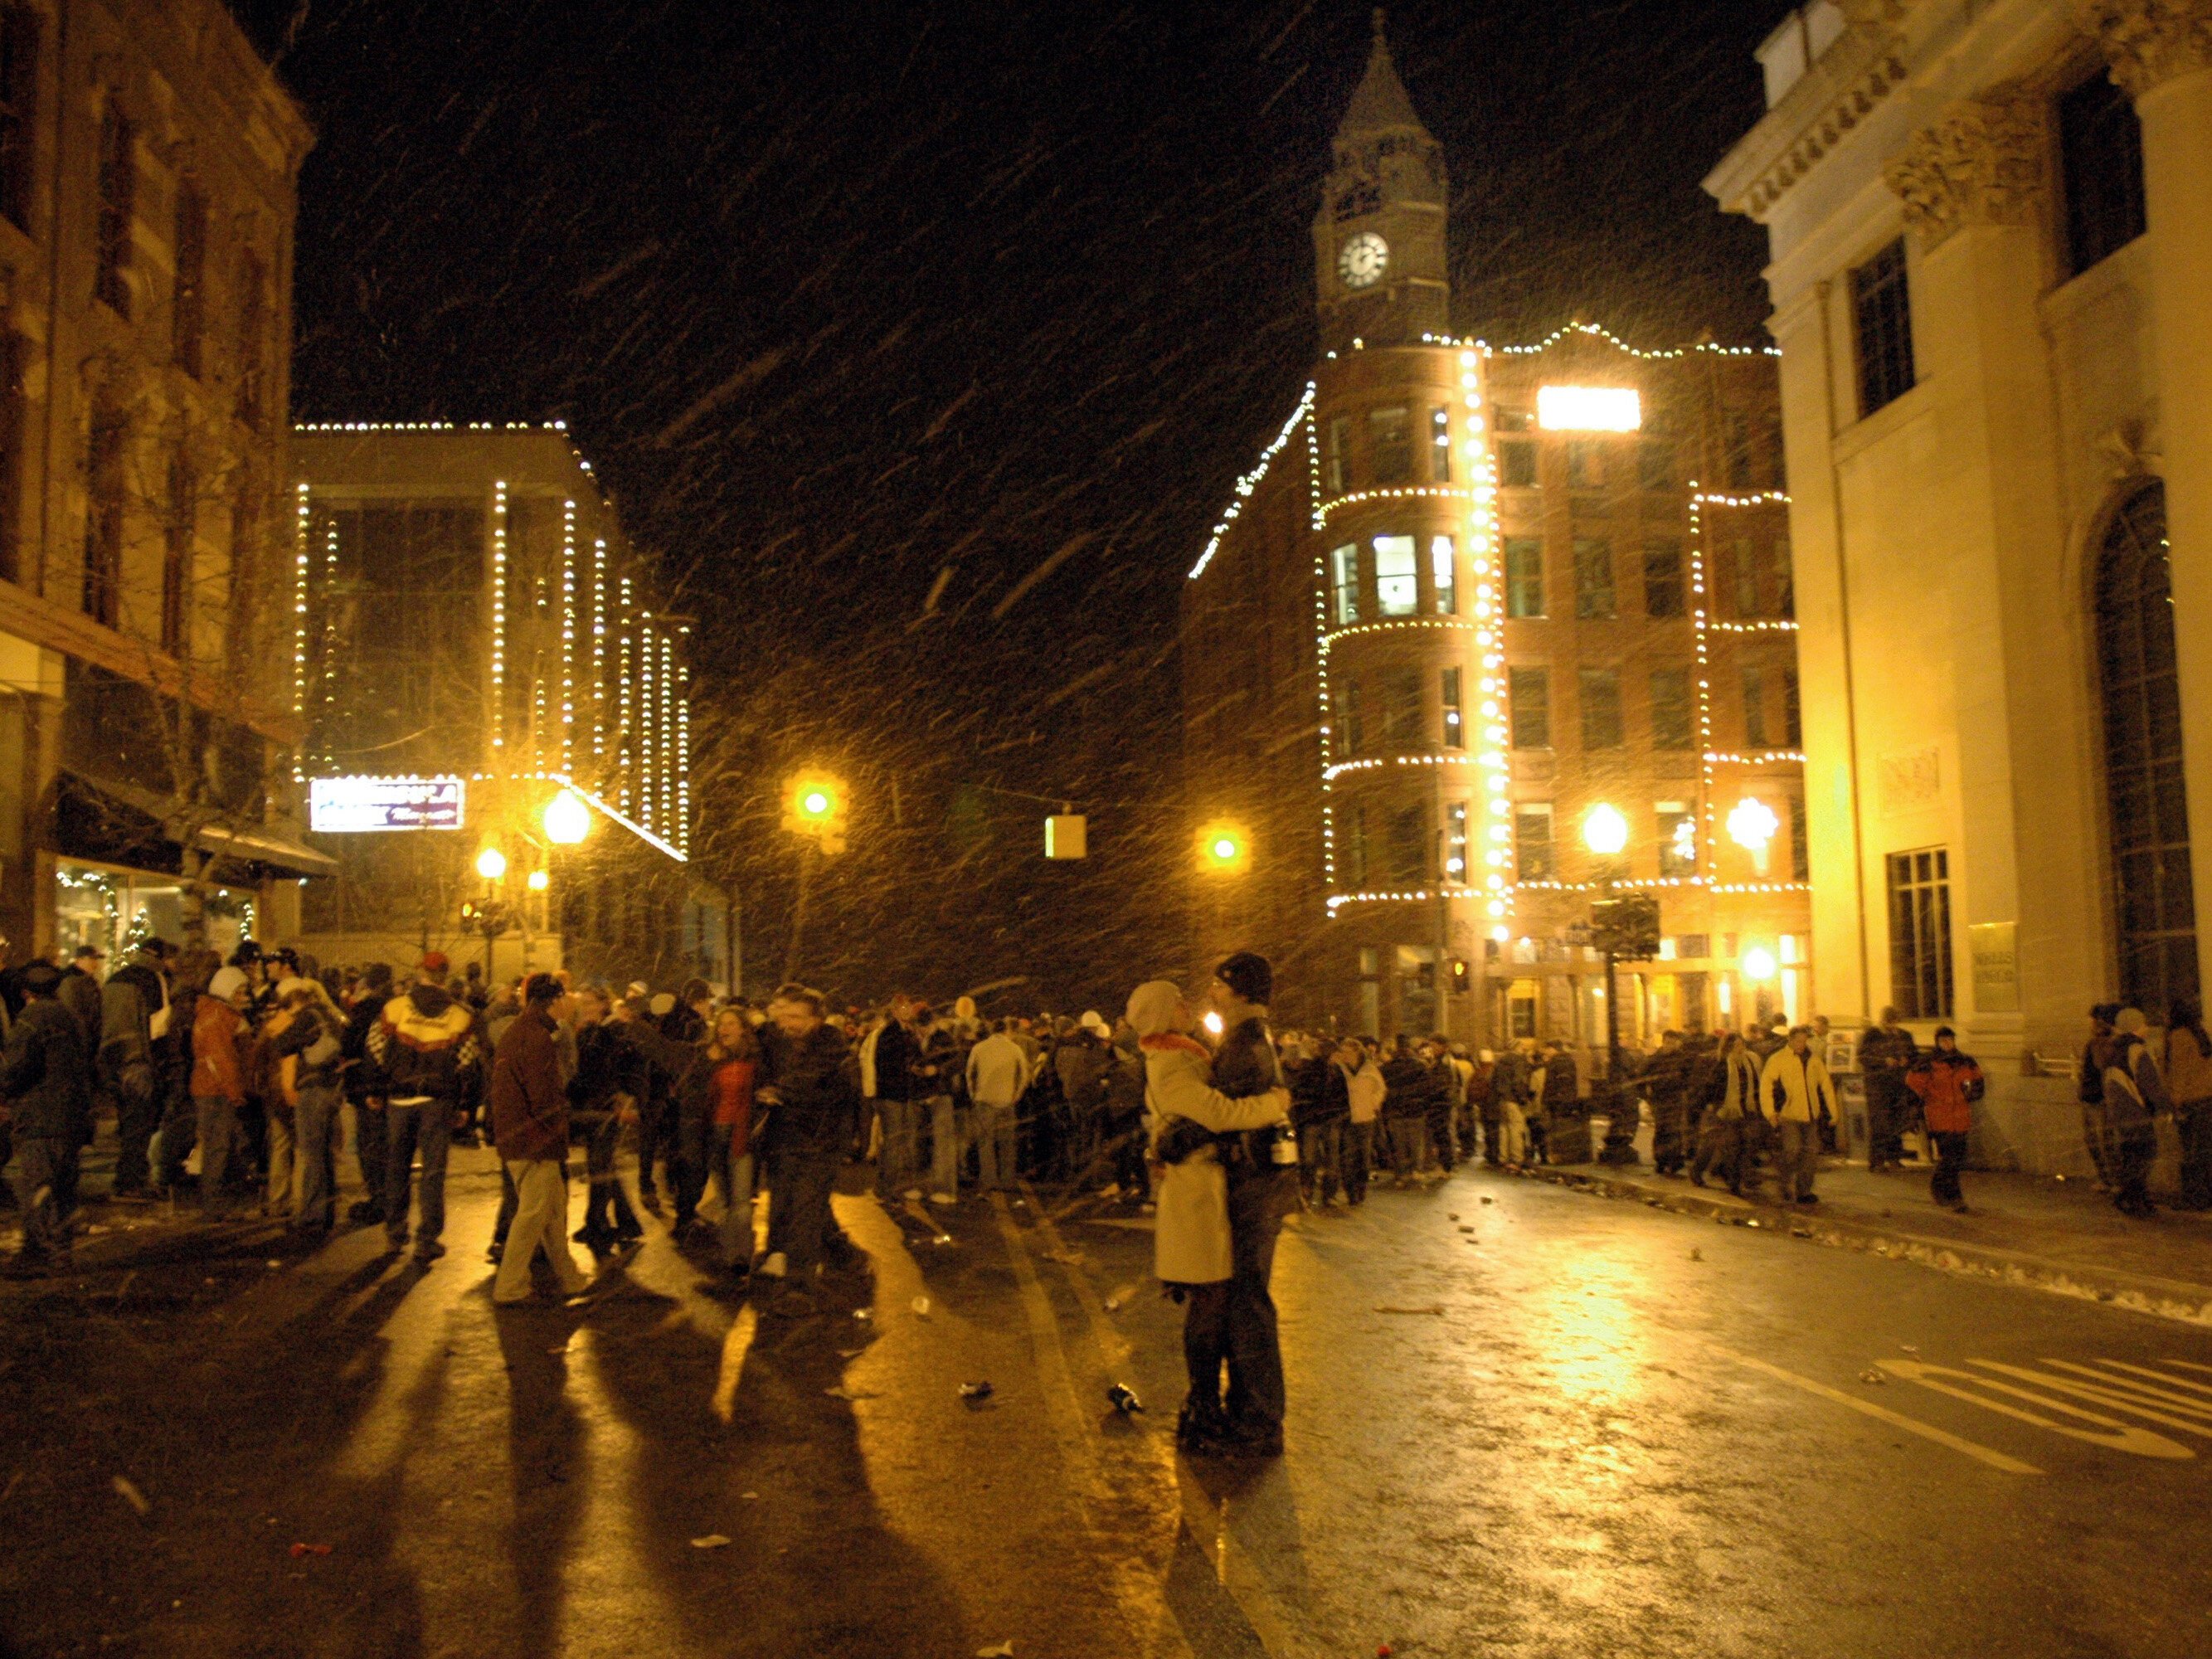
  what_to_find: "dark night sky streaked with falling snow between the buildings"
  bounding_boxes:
[236,0,1787,1009]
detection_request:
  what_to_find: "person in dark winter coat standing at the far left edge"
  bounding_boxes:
[0,962,93,1278]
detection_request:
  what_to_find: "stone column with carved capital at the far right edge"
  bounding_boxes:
[2077,0,2212,986]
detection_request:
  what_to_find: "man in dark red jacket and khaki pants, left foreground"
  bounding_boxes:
[491,973,586,1307]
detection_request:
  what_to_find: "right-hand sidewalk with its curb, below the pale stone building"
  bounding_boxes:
[1526,1124,2212,1325]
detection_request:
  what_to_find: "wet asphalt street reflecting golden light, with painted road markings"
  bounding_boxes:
[0,1155,2212,1659]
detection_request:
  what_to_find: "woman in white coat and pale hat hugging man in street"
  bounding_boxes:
[1128,980,1290,1451]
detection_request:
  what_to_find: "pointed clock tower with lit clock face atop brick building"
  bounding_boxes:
[1314,9,1451,352]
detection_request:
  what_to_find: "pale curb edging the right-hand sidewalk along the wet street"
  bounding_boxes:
[1522,1168,2212,1330]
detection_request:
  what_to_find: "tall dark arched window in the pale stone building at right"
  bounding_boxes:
[2097,484,2196,1013]
